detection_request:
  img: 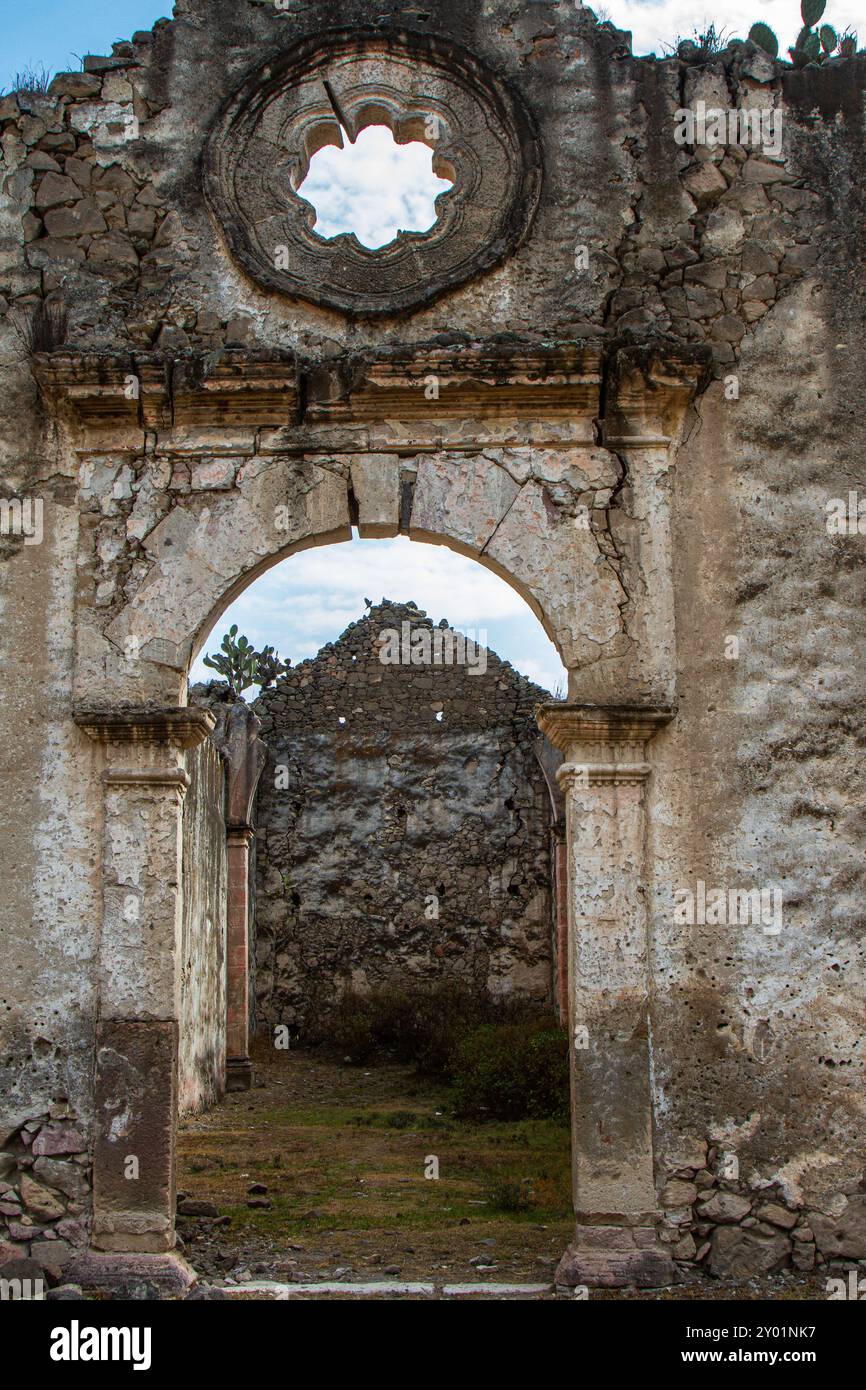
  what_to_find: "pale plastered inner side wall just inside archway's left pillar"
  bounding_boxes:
[178,738,228,1113]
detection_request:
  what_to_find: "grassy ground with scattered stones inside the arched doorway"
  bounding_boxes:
[178,1048,571,1283]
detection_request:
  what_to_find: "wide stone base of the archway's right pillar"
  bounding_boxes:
[555,1226,683,1289]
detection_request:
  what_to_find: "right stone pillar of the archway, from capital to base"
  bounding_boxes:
[538,705,677,1286]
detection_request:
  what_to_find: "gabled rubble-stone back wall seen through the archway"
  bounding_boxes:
[254,600,552,1026]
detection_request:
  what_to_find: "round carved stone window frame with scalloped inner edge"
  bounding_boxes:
[204,29,542,316]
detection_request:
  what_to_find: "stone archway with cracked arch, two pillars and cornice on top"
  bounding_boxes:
[38,333,701,1283]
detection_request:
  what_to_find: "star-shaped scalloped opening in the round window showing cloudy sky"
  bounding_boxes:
[297,125,455,250]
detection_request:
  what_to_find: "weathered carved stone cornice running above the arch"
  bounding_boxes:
[33,339,706,449]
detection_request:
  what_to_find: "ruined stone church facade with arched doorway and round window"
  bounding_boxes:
[0,0,866,1287]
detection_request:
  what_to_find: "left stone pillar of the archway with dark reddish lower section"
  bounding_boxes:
[76,709,214,1252]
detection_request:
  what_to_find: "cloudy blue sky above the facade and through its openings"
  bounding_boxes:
[6,0,866,691]
